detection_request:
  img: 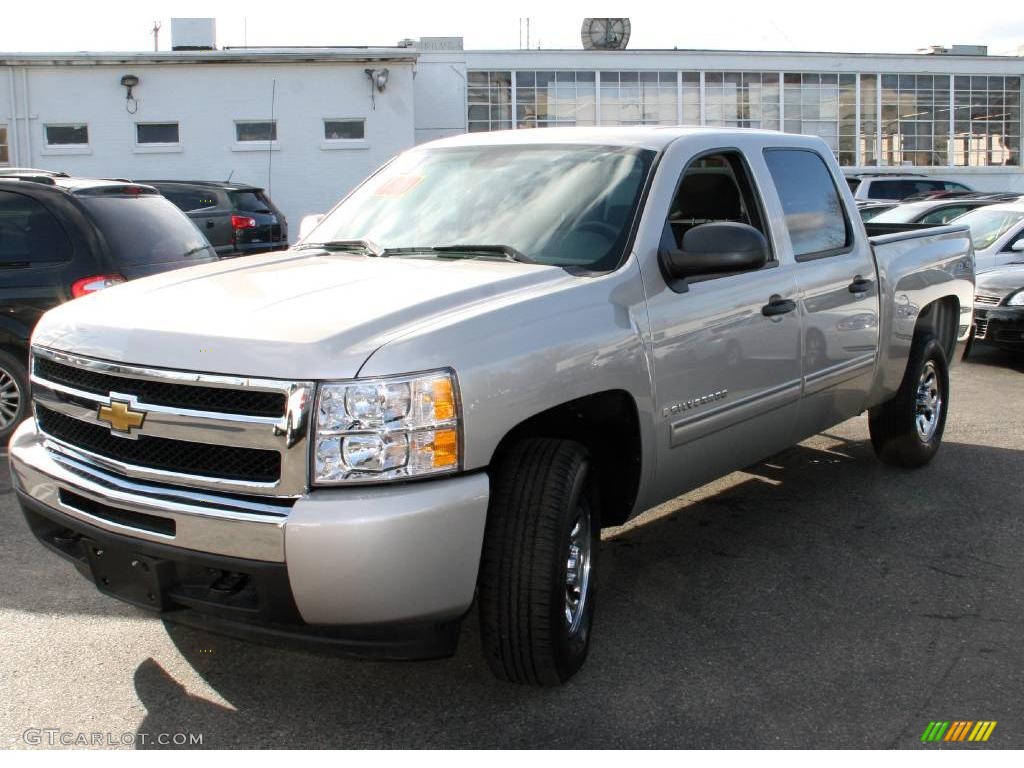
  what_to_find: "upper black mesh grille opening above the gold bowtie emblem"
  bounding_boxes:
[35,356,286,417]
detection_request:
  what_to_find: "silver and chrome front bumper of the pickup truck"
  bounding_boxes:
[10,420,488,657]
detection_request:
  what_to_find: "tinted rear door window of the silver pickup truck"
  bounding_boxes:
[765,150,850,259]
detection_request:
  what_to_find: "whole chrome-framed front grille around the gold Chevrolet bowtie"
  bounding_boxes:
[32,347,313,498]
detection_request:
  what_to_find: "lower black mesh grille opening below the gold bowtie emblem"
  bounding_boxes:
[36,404,281,482]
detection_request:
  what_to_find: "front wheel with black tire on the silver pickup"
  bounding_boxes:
[479,438,601,686]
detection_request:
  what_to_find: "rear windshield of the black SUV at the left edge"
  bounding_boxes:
[77,193,216,266]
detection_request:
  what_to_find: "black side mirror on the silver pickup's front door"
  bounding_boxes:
[658,221,768,291]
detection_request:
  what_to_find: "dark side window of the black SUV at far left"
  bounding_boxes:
[0,191,73,270]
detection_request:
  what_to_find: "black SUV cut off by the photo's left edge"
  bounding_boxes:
[0,169,217,442]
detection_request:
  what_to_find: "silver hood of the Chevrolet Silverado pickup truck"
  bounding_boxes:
[33,251,579,379]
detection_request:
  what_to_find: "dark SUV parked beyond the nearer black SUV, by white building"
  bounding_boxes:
[138,179,288,257]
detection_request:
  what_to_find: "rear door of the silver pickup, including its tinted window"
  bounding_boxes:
[764,147,879,436]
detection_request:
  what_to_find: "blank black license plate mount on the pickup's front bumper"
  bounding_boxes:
[82,539,174,610]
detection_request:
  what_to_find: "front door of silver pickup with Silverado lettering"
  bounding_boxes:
[641,144,800,499]
